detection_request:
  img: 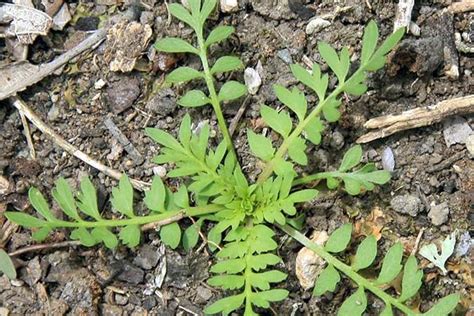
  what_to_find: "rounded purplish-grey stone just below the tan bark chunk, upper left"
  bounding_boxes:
[107,77,140,114]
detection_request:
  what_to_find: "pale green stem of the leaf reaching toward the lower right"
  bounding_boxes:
[277,224,418,316]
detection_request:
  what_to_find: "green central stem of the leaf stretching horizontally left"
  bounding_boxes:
[47,205,223,228]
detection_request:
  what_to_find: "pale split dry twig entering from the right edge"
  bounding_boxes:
[357,95,474,143]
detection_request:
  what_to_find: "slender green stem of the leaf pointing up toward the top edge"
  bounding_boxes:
[196,28,239,163]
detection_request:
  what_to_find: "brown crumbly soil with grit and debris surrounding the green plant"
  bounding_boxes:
[0,0,474,315]
